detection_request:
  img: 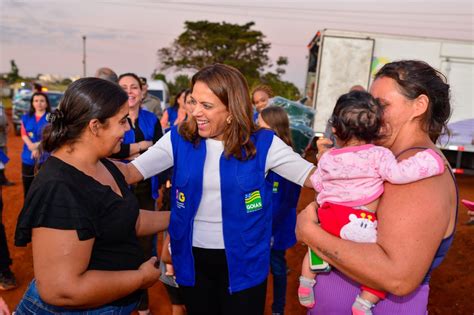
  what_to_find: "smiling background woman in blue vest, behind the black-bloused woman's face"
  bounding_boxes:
[111,73,163,314]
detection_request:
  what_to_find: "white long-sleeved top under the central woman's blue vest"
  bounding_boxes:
[132,132,314,249]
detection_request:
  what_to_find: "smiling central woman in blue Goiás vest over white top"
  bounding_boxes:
[120,64,314,315]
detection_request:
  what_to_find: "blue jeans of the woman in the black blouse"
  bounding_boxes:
[15,279,137,315]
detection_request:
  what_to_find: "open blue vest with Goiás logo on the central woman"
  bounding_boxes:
[168,128,273,293]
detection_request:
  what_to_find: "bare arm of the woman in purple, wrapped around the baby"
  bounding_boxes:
[296,165,456,295]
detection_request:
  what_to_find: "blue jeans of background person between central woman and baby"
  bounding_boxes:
[270,249,287,314]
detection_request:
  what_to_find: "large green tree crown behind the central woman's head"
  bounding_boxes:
[158,21,299,99]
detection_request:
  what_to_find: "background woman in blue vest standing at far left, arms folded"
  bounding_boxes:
[21,92,51,198]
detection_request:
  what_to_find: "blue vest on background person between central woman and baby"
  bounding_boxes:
[267,171,301,250]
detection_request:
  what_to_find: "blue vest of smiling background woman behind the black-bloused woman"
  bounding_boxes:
[123,108,160,199]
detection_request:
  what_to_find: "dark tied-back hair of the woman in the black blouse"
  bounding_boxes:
[42,78,128,152]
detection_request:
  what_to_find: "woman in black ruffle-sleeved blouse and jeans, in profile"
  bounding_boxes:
[15,78,169,314]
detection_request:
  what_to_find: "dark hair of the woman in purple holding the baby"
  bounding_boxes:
[375,60,451,142]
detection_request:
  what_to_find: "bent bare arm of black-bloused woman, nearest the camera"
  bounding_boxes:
[33,228,160,308]
